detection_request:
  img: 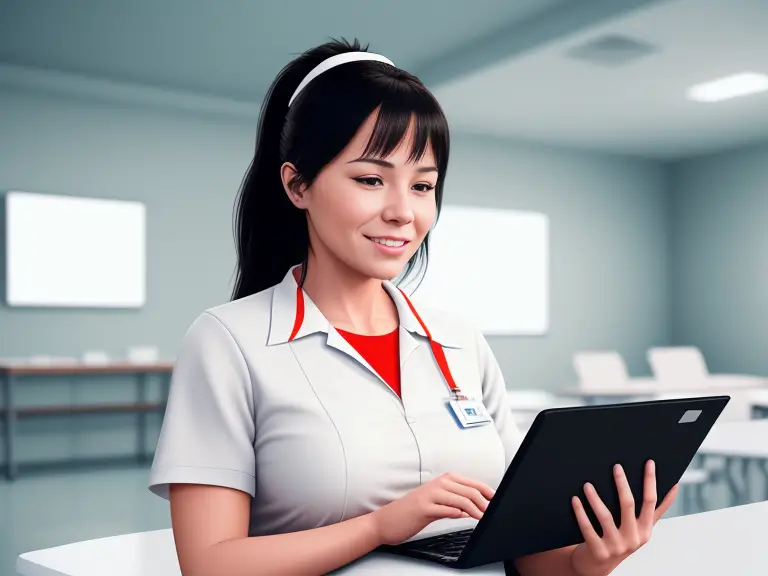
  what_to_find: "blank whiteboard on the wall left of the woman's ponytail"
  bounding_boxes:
[5,192,146,308]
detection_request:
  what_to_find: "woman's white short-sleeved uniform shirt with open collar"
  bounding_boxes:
[150,270,521,536]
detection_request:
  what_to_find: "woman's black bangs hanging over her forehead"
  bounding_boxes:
[363,81,450,181]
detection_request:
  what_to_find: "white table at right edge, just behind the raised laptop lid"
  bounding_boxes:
[696,419,768,504]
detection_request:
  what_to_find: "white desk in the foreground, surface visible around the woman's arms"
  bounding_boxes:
[17,502,768,576]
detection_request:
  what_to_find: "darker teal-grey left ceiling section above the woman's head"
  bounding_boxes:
[0,0,653,109]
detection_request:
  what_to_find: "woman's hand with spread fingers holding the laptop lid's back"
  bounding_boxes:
[571,460,678,576]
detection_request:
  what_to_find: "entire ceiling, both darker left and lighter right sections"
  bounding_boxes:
[0,0,756,159]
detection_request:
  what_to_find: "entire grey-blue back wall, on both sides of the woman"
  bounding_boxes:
[0,90,669,462]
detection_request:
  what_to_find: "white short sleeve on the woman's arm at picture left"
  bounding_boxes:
[149,312,256,499]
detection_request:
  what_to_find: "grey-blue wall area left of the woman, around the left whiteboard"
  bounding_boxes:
[0,91,255,357]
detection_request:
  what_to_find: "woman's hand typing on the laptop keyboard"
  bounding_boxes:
[371,473,494,545]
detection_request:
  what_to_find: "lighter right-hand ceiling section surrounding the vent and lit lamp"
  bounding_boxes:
[436,0,768,160]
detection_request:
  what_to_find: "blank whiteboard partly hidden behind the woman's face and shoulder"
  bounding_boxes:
[404,206,549,335]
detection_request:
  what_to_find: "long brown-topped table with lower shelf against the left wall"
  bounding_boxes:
[0,361,173,480]
